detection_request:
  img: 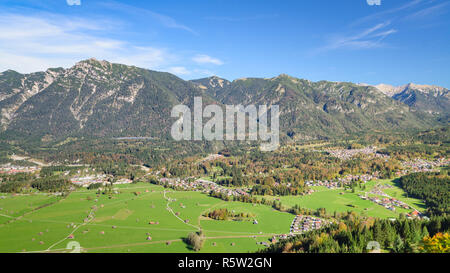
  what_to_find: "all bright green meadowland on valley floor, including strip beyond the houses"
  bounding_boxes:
[0,180,424,253]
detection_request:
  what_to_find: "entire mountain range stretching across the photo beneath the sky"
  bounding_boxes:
[0,59,450,143]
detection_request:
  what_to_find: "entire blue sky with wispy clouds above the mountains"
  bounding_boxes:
[0,0,450,88]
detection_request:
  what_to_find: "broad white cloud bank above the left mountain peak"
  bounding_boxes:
[0,14,178,73]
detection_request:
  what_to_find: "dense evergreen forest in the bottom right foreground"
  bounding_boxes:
[261,214,450,253]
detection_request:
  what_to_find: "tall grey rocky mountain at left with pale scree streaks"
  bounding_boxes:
[0,59,209,136]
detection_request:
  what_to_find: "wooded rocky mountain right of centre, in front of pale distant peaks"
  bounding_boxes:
[197,75,440,139]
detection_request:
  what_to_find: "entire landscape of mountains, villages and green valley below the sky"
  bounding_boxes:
[0,59,450,253]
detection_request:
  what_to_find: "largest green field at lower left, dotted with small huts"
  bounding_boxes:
[0,183,293,252]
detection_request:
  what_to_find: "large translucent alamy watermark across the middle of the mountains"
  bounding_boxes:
[171,97,280,151]
